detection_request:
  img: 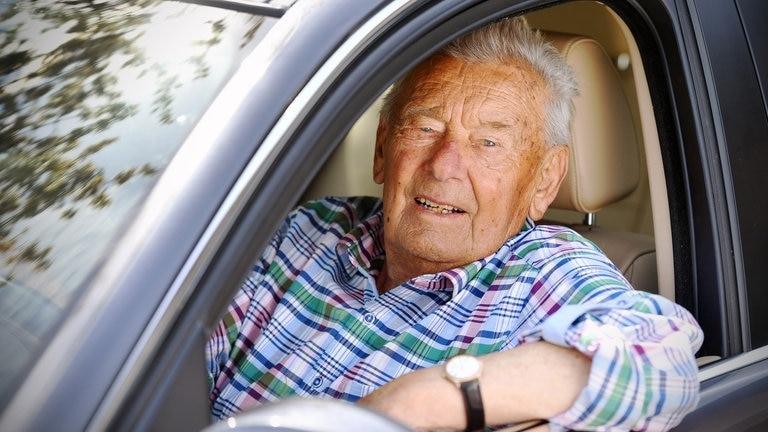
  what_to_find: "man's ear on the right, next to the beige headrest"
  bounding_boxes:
[528,145,571,220]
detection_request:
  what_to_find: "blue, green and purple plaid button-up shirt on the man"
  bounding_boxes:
[206,198,702,430]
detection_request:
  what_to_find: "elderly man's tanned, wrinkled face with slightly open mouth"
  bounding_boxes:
[374,57,560,272]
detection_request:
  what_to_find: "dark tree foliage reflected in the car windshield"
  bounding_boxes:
[0,0,260,277]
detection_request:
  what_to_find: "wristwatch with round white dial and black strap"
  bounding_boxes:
[445,354,485,431]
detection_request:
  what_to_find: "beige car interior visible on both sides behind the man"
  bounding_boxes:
[304,2,675,299]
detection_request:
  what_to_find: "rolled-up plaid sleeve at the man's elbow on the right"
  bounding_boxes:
[523,290,703,431]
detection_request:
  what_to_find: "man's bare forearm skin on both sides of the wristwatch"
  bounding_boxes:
[360,342,590,430]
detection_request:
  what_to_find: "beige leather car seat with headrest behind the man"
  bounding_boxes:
[544,32,658,293]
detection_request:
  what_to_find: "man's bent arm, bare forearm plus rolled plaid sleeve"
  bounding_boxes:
[362,291,703,430]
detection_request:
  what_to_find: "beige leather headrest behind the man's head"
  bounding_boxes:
[543,32,640,213]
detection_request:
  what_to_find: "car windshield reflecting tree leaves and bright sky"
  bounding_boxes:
[0,0,274,399]
